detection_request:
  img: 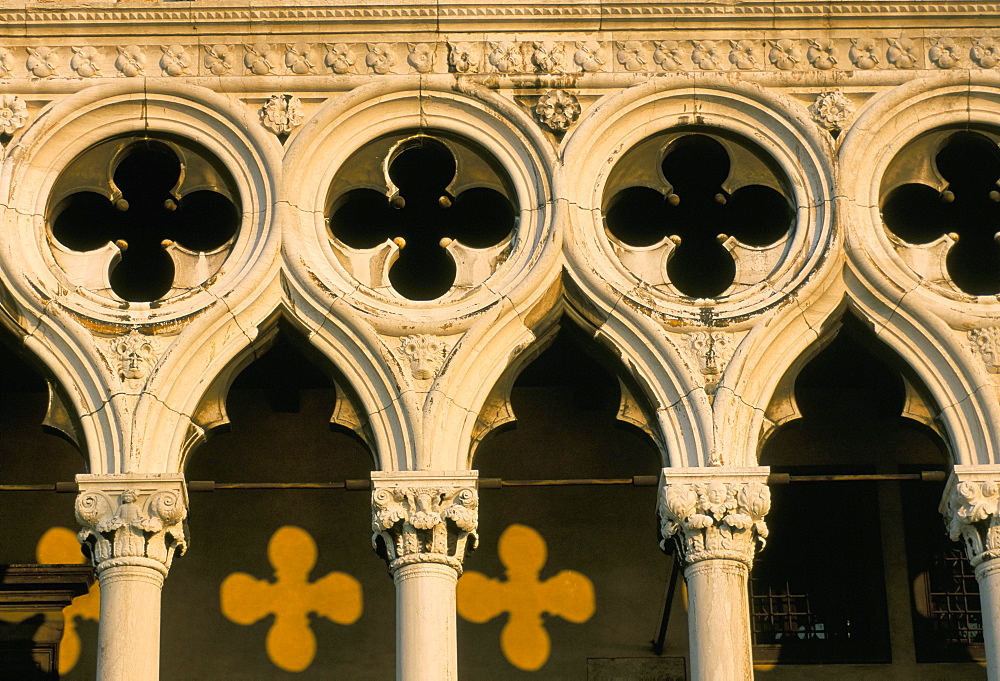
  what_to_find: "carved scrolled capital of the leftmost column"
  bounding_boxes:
[76,474,187,577]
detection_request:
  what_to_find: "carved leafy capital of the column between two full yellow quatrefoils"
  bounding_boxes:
[372,471,479,574]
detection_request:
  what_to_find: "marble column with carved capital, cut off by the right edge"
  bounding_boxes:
[940,466,1000,681]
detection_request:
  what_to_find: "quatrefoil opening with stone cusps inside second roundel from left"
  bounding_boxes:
[327,134,517,300]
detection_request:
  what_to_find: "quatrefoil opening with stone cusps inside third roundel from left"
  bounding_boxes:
[604,131,795,298]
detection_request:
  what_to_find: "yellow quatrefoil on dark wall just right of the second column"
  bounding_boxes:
[458,525,595,672]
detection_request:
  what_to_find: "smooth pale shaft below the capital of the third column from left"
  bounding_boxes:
[684,560,753,681]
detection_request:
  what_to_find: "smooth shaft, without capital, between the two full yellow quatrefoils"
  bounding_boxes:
[393,563,458,681]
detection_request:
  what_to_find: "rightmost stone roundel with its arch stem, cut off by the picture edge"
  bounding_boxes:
[841,73,1000,464]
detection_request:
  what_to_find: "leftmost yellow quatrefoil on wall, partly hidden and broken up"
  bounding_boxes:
[0,527,101,674]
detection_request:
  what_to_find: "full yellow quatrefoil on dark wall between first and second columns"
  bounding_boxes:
[219,525,362,672]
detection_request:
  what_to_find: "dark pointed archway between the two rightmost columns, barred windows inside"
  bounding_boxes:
[750,317,981,664]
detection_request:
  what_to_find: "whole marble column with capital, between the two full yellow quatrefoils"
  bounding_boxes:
[372,471,479,681]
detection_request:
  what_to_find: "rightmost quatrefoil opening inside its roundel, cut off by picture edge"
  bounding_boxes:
[882,131,1000,295]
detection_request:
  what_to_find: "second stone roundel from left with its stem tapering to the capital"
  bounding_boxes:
[283,78,562,470]
